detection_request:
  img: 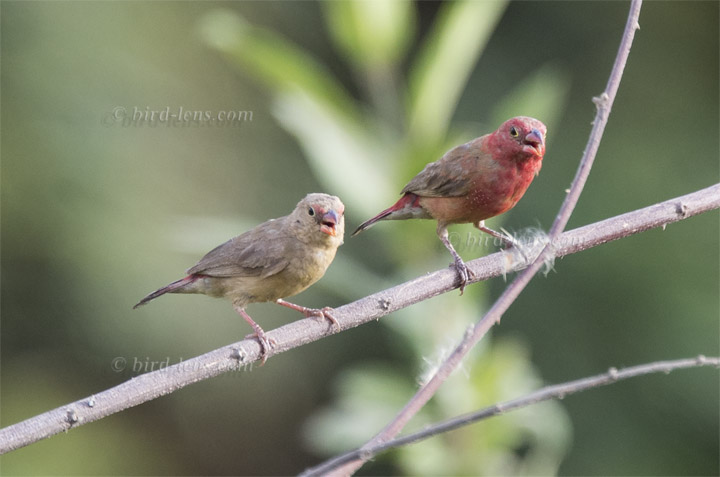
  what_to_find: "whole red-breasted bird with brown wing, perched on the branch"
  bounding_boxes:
[353,116,547,294]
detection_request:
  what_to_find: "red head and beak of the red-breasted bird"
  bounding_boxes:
[492,116,547,159]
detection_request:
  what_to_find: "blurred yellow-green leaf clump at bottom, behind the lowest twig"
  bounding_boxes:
[396,339,569,475]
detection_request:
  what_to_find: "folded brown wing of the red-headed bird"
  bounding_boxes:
[401,138,482,197]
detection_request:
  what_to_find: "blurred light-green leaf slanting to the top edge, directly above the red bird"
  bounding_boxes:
[408,0,507,144]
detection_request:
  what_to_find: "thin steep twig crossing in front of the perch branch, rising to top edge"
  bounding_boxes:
[330,0,642,476]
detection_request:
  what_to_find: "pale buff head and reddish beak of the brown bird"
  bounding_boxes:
[291,193,345,248]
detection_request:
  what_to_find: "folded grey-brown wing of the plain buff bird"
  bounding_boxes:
[187,217,290,278]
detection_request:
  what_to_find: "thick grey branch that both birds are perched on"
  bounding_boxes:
[0,179,720,454]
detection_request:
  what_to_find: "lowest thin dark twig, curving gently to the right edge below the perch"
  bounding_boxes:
[300,355,720,477]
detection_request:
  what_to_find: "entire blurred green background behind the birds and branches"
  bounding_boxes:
[0,1,720,475]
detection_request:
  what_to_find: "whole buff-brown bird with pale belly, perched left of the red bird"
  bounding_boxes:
[133,194,345,363]
